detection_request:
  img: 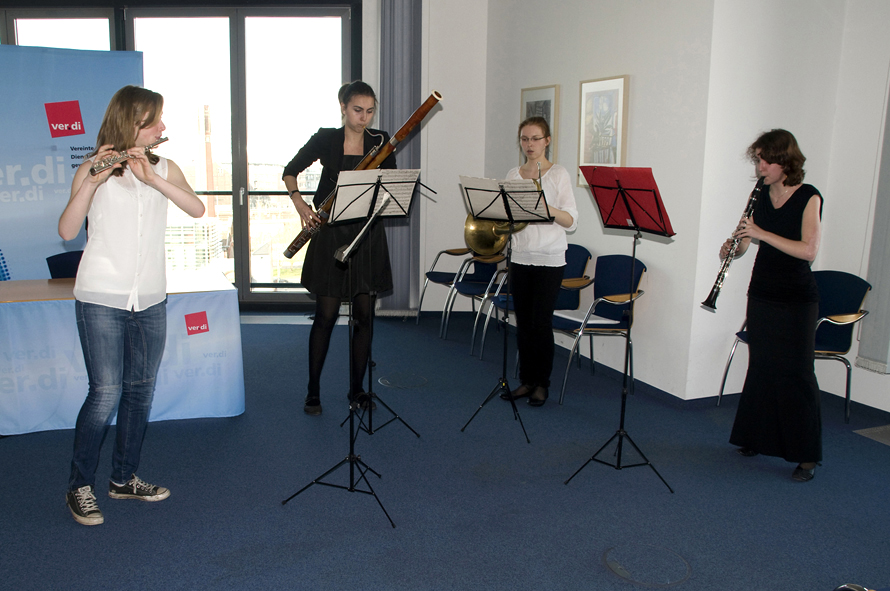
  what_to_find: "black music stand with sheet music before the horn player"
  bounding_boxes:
[460,176,553,443]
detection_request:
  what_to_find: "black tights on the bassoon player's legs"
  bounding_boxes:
[308,293,371,397]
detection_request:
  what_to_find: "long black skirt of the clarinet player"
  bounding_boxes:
[729,297,822,463]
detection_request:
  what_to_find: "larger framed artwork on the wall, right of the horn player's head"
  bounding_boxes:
[578,76,628,186]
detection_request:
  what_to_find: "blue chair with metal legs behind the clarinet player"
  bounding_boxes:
[717,271,871,423]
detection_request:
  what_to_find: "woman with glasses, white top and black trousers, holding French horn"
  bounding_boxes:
[501,117,578,406]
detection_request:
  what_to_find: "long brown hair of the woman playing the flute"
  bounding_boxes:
[91,86,164,176]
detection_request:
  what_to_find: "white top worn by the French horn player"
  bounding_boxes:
[507,164,578,267]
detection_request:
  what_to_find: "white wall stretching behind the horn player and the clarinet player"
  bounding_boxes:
[421,0,890,409]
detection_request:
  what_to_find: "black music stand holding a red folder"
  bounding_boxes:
[564,166,675,493]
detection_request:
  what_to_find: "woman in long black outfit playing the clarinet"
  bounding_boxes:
[720,129,822,482]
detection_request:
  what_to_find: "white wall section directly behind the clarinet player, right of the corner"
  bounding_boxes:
[684,0,844,398]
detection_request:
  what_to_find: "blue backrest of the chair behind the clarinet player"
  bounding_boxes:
[813,271,871,355]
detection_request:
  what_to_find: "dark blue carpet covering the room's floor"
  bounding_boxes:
[0,314,890,591]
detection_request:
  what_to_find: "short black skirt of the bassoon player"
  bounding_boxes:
[301,220,392,298]
